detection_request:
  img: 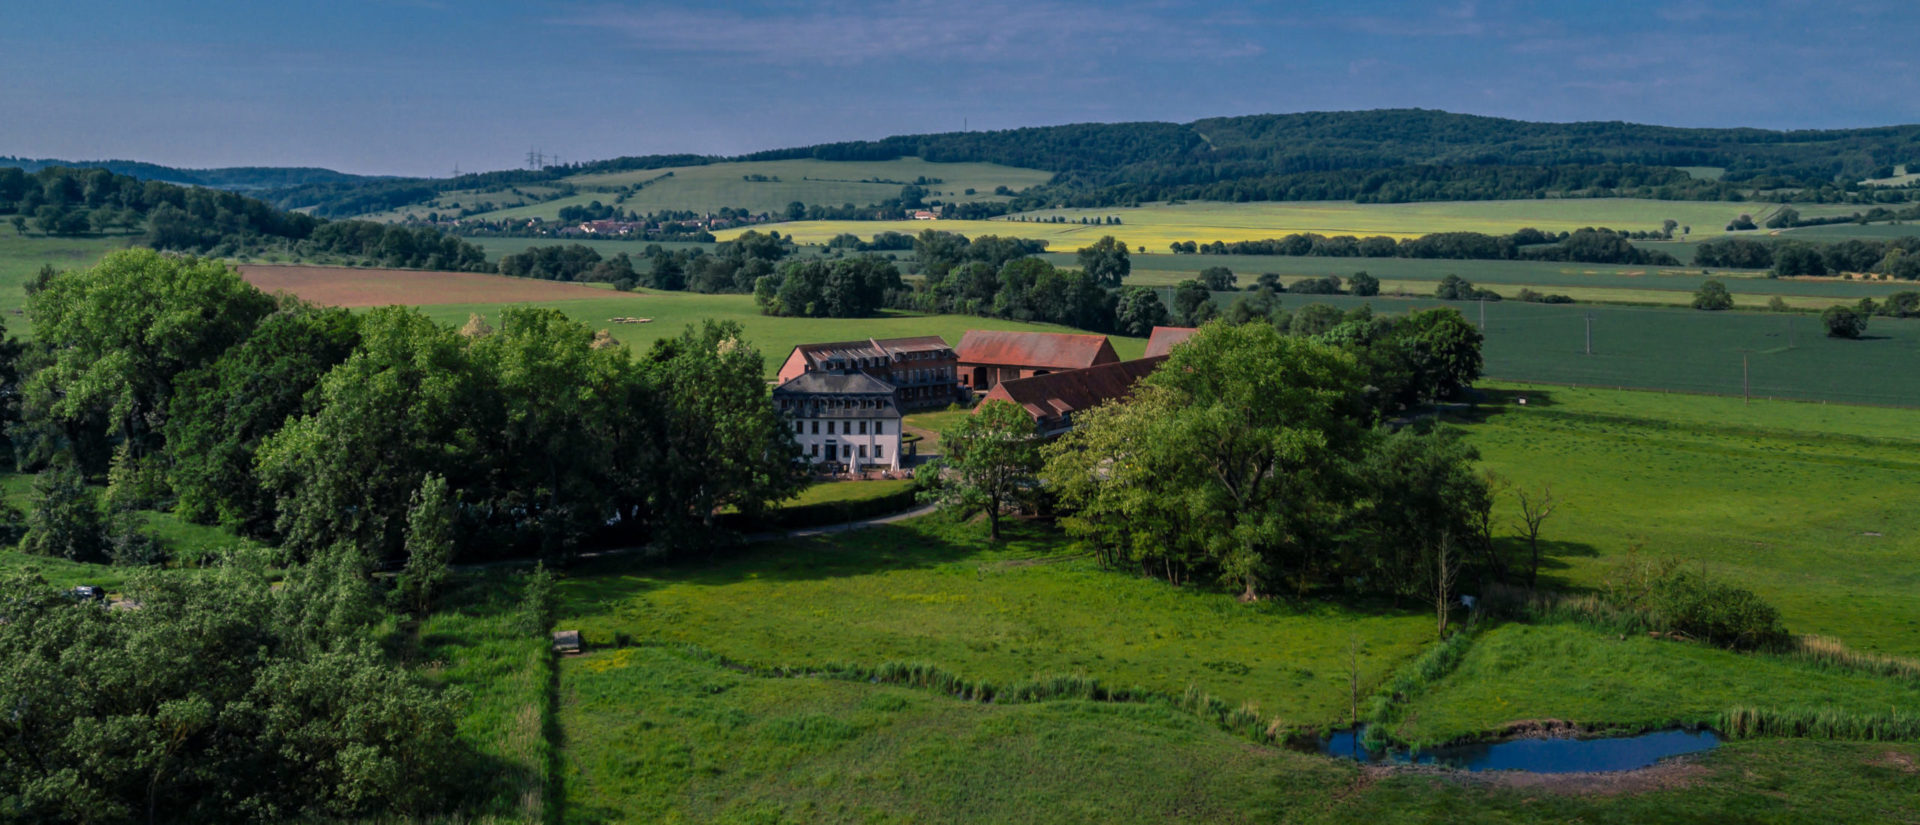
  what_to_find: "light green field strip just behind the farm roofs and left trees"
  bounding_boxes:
[408,292,1146,374]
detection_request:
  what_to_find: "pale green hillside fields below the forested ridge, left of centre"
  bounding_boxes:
[432,157,1052,221]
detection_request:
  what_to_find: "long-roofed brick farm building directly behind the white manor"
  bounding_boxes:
[780,336,964,411]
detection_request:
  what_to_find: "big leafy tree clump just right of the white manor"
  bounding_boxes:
[931,316,1505,625]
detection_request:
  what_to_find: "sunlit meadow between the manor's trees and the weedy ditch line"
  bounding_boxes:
[563,518,1432,723]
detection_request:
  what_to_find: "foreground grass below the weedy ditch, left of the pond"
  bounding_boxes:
[561,648,1354,823]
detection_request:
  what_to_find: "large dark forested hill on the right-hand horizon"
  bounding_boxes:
[756,109,1920,186]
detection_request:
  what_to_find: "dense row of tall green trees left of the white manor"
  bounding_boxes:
[8,249,799,560]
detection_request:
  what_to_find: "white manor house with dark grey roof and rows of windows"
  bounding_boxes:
[774,372,900,472]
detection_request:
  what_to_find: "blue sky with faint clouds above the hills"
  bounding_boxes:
[0,0,1920,175]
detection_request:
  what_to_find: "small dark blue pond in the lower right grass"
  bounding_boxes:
[1319,727,1720,773]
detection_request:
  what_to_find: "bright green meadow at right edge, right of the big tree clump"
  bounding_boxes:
[1469,388,1920,656]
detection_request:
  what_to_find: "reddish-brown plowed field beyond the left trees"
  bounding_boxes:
[240,265,616,307]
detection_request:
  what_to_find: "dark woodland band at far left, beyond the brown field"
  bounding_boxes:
[0,167,490,272]
